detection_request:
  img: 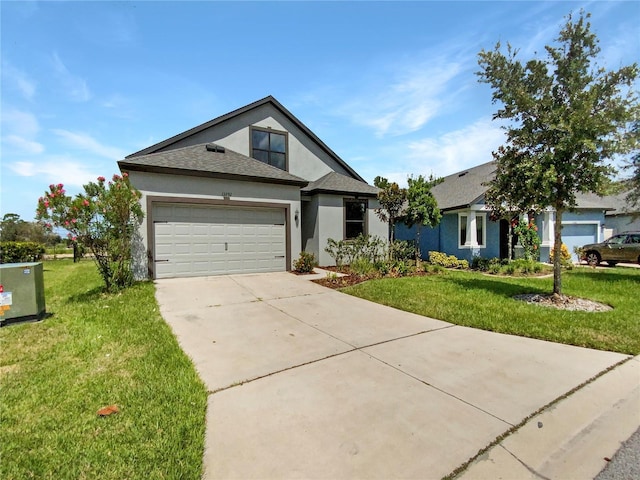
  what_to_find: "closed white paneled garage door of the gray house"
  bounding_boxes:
[152,204,286,278]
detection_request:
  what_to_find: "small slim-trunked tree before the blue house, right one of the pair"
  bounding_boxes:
[403,175,442,260]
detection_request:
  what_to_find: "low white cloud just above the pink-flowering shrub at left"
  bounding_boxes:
[8,156,98,190]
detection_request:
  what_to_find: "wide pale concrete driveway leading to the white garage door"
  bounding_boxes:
[156,273,638,479]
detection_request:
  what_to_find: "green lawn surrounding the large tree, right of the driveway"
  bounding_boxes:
[342,268,640,355]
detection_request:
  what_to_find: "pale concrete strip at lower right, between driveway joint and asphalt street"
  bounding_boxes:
[452,356,640,480]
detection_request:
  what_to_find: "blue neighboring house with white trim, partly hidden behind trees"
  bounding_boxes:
[395,162,615,262]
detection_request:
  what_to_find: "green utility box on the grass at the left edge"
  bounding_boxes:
[0,262,46,326]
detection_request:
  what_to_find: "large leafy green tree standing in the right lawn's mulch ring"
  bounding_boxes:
[478,11,638,295]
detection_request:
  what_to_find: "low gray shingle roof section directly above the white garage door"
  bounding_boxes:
[118,143,309,187]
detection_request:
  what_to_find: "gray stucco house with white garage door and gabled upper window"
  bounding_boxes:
[118,96,388,278]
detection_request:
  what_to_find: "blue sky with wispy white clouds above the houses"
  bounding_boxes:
[0,1,640,220]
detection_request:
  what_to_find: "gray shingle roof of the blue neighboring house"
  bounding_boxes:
[431,161,615,210]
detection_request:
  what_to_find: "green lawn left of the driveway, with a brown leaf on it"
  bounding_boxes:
[0,260,207,480]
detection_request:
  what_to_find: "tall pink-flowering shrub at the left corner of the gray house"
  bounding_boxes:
[36,173,143,291]
